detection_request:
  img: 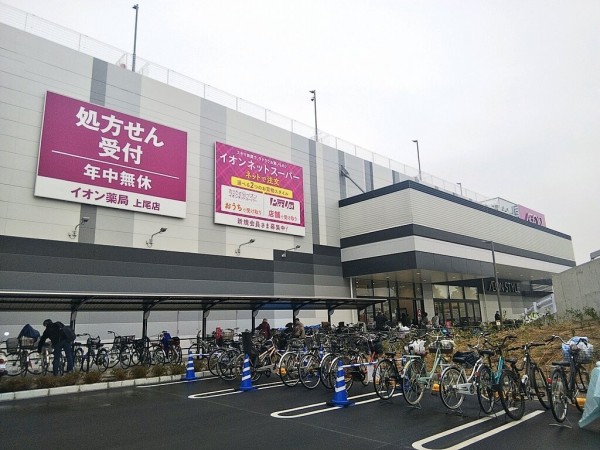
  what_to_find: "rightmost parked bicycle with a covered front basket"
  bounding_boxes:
[548,335,591,422]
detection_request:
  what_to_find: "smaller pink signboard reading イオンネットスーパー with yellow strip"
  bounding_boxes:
[215,142,305,236]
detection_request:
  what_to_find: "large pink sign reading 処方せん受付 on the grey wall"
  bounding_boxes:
[35,92,187,217]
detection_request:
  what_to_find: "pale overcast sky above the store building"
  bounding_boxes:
[0,0,600,264]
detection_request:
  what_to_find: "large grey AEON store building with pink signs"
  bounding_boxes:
[0,9,575,334]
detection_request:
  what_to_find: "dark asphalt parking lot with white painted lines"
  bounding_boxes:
[0,376,600,450]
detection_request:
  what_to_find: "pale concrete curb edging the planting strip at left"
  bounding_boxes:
[0,372,210,403]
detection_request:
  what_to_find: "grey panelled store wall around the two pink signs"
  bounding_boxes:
[0,24,408,338]
